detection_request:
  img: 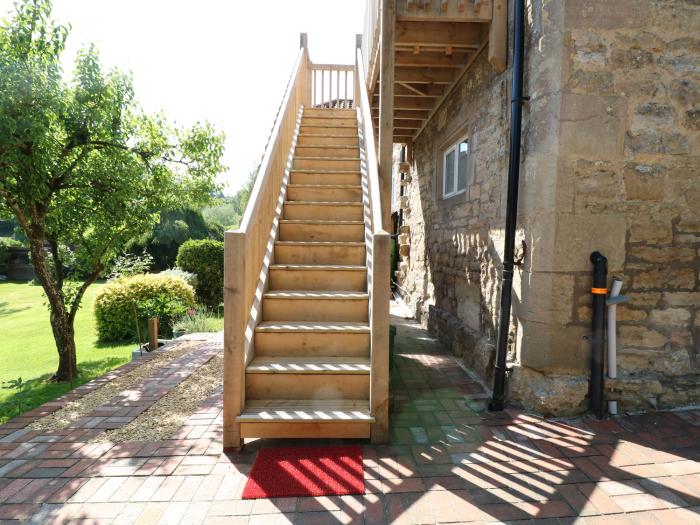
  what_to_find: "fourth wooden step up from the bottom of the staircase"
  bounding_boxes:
[263,290,369,322]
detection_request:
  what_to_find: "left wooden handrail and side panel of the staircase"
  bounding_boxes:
[223,39,311,449]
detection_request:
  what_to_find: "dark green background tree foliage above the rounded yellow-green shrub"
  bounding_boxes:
[129,209,224,271]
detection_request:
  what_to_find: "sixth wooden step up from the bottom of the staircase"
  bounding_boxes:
[275,241,366,265]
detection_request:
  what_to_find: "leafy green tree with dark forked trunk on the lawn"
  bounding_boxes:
[0,0,223,381]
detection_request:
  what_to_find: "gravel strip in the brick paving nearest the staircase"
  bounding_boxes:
[95,354,224,443]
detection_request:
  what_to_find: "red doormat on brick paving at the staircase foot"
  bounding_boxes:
[243,445,365,499]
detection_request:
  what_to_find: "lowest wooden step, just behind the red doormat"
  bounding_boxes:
[236,399,374,439]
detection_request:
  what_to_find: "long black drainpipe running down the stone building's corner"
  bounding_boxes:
[489,0,525,411]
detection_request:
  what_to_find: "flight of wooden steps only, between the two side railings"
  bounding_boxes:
[236,109,374,438]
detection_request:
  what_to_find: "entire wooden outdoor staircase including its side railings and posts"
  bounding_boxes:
[224,36,390,448]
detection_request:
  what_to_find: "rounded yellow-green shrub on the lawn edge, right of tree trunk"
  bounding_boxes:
[93,274,195,341]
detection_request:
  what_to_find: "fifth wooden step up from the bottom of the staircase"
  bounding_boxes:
[270,264,367,292]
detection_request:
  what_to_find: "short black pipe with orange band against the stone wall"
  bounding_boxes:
[588,252,608,419]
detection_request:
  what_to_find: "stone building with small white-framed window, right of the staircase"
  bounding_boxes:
[395,0,700,415]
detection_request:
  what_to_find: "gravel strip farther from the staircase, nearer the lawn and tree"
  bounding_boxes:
[29,341,202,432]
